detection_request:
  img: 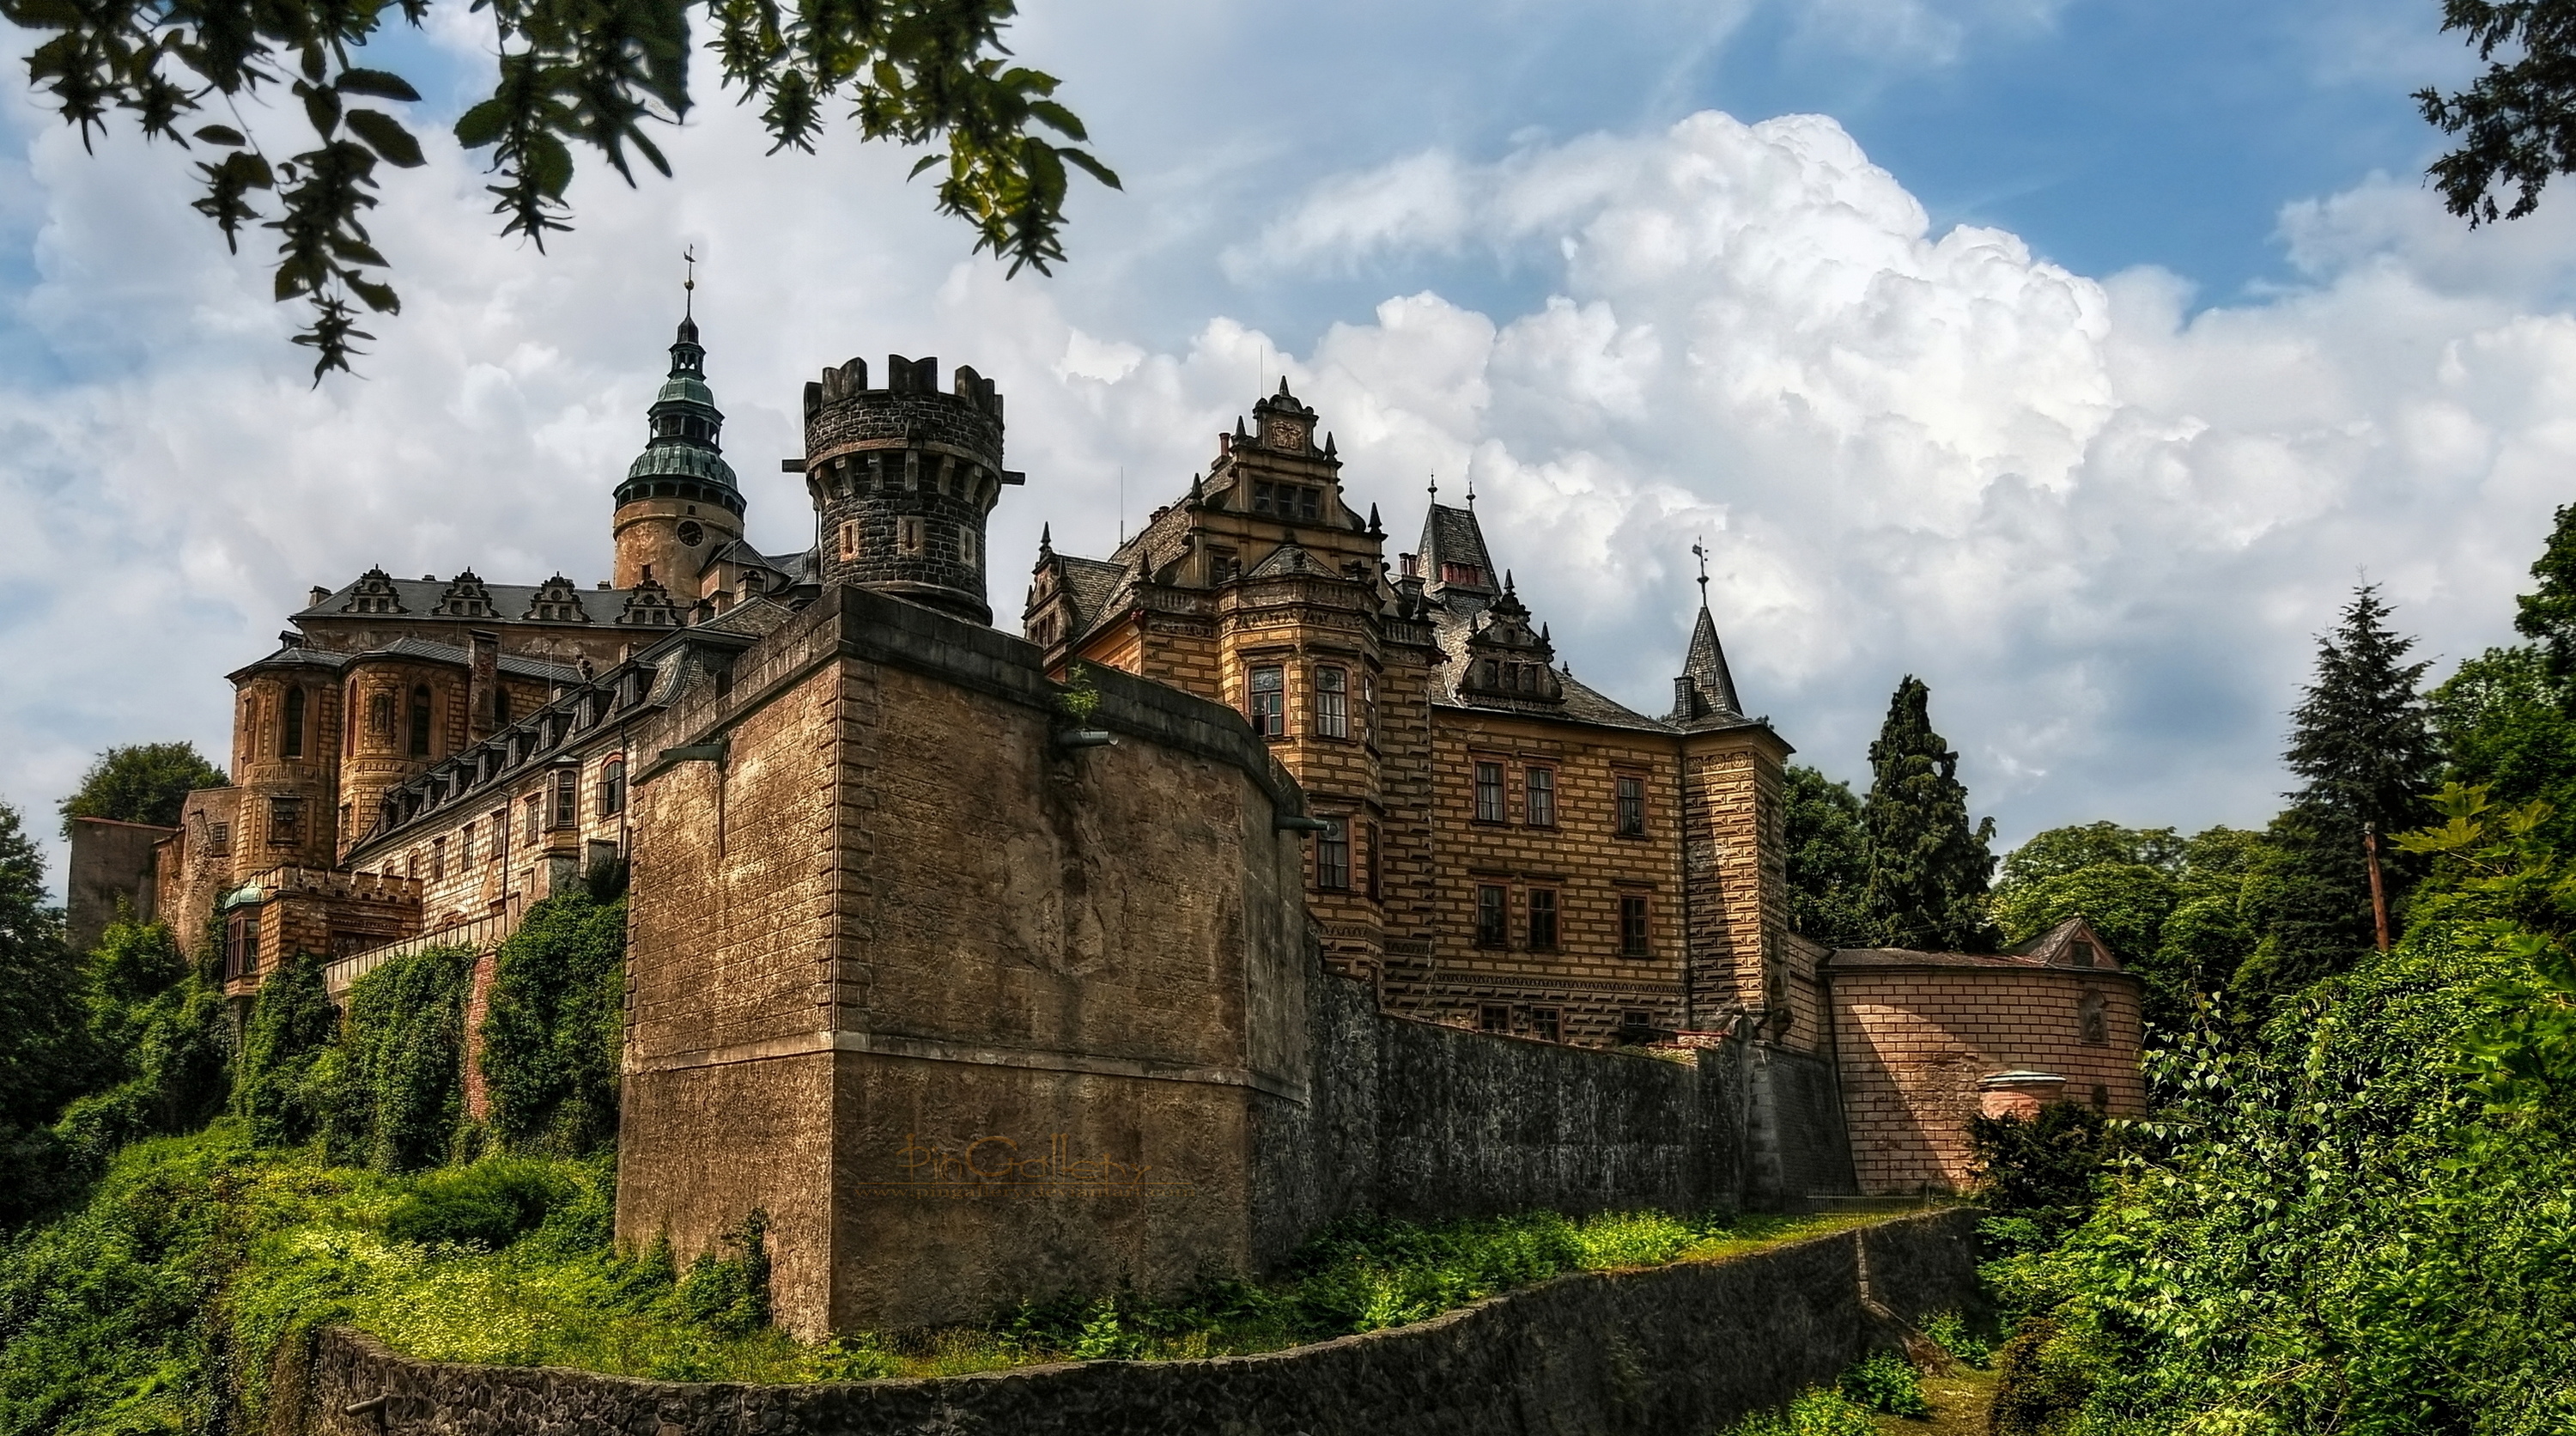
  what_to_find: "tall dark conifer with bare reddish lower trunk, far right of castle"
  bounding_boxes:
[2236,582,2437,1021]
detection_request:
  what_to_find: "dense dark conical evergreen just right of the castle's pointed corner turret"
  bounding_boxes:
[1860,672,1996,952]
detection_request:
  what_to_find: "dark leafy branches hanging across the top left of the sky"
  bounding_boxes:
[0,0,1118,384]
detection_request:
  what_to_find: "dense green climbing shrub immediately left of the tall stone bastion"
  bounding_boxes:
[482,895,626,1155]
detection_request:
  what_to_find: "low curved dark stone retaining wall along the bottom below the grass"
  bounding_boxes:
[287,1209,1976,1436]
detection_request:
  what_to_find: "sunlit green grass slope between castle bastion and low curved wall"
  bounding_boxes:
[0,1122,1937,1436]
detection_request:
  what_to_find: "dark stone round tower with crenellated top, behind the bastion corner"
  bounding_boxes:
[804,356,1020,624]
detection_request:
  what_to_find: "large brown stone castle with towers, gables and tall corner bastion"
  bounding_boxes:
[100,307,2143,1333]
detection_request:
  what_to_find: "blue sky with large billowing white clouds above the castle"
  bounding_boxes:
[0,0,2576,892]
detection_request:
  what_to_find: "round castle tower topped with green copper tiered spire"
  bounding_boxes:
[613,317,742,593]
